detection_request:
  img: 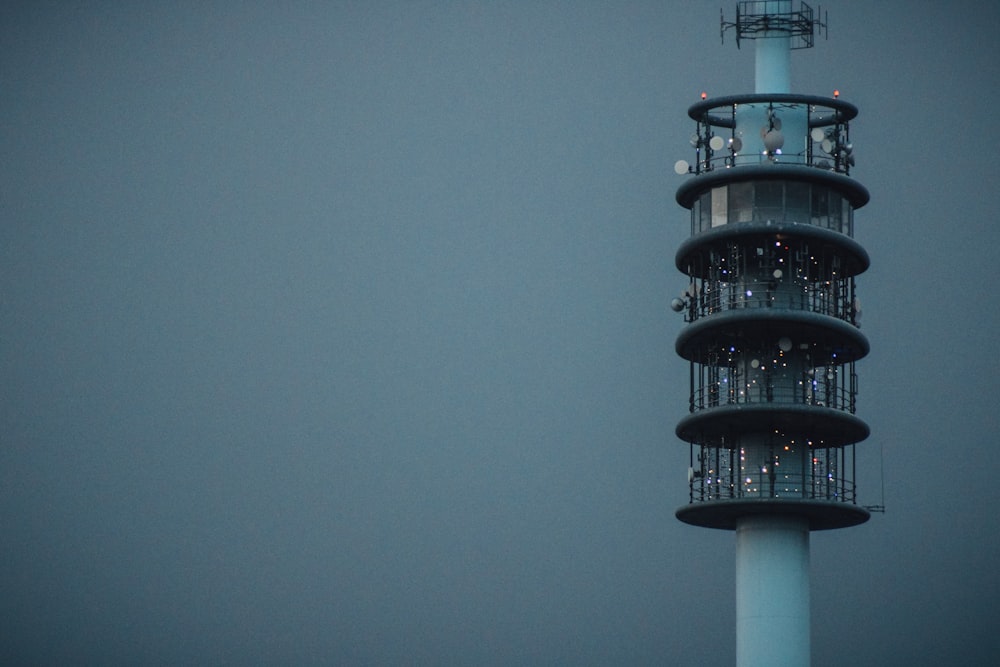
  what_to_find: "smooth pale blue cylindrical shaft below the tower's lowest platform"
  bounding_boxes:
[736,515,809,667]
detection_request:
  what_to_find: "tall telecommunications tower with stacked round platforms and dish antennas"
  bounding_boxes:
[671,0,869,667]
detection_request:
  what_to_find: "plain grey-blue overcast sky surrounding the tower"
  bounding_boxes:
[0,0,1000,667]
